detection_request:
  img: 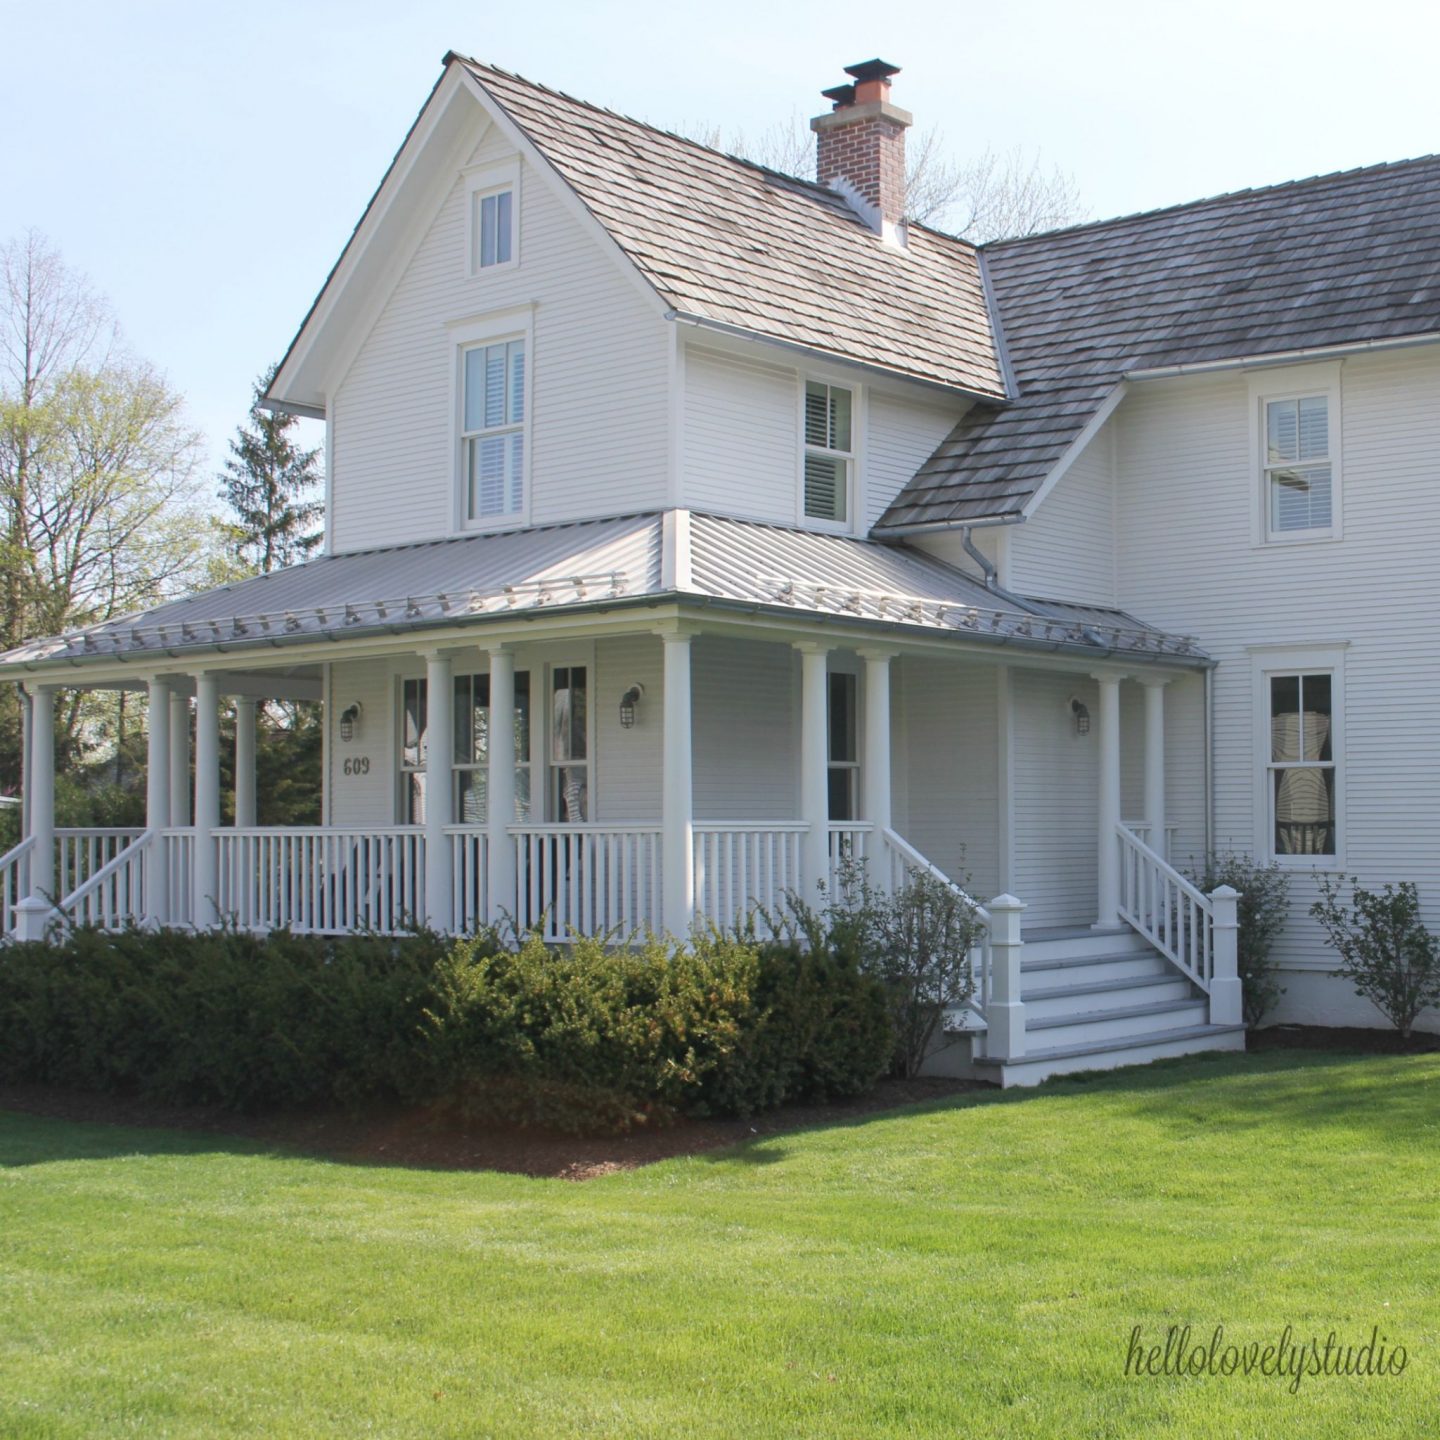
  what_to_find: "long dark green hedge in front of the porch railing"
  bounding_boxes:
[0,930,893,1130]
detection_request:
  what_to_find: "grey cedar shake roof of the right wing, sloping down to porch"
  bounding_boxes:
[876,156,1440,534]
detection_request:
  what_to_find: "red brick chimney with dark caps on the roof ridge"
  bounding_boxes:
[811,60,912,245]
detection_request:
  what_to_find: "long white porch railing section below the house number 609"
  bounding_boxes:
[213,825,425,935]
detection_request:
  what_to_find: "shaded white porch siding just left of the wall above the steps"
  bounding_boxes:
[893,658,999,900]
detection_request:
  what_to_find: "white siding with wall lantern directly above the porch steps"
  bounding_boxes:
[1011,670,1099,926]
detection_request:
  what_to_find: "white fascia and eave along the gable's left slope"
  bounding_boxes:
[268,65,474,418]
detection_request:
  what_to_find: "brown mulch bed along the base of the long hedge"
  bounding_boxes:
[0,1080,992,1179]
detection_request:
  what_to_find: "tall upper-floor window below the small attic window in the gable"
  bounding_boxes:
[461,336,526,521]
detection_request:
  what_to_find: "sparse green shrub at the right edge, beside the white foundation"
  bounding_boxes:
[1310,876,1440,1040]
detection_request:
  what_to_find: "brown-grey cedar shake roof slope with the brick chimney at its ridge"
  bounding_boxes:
[452,56,1005,397]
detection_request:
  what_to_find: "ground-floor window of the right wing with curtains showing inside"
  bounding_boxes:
[1267,672,1336,857]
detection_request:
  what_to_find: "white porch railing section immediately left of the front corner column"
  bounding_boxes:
[510,825,661,940]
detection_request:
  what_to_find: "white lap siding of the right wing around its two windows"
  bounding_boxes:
[1117,347,1440,1019]
